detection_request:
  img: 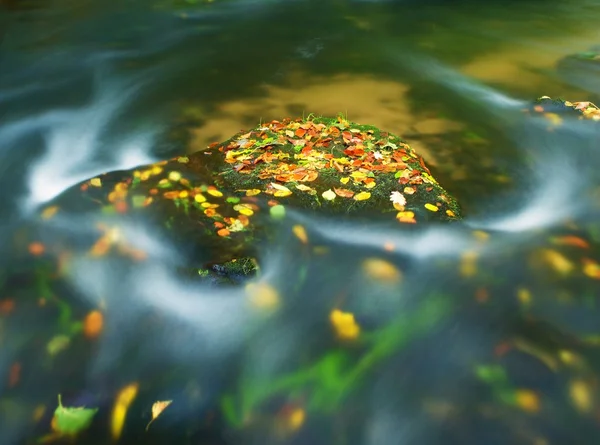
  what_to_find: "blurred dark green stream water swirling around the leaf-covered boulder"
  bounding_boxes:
[0,0,600,445]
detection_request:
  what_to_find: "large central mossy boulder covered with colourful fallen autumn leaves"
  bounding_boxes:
[46,117,460,265]
